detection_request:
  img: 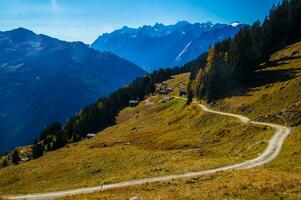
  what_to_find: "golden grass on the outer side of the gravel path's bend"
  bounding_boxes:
[58,42,301,200]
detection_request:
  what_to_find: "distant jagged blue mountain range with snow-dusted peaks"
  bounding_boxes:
[92,21,245,71]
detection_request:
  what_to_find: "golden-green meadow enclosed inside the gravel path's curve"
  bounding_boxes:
[0,74,272,194]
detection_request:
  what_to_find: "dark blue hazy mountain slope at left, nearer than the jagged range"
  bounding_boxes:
[0,28,145,152]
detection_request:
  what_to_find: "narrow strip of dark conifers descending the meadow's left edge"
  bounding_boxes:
[32,66,190,158]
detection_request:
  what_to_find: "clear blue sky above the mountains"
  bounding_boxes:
[0,0,280,43]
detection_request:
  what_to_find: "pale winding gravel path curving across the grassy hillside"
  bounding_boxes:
[5,97,291,200]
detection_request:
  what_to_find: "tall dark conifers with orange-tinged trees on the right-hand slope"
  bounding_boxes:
[191,0,301,102]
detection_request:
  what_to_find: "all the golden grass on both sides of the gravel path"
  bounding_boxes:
[0,43,301,199]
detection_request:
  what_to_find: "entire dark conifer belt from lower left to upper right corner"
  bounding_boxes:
[32,0,301,158]
